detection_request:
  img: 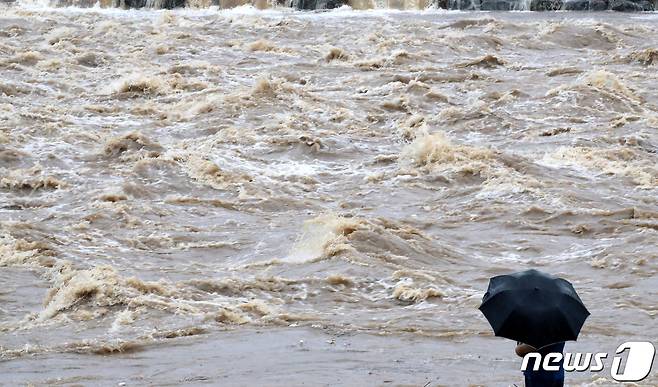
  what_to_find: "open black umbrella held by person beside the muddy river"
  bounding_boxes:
[479,270,589,348]
